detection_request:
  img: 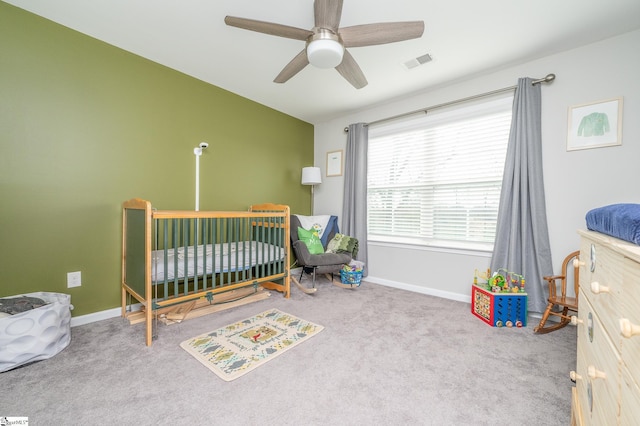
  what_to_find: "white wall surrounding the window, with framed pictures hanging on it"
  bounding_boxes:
[315,31,640,301]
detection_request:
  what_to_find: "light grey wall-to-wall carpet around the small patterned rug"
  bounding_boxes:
[0,278,576,426]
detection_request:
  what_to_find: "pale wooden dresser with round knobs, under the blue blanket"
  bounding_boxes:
[571,231,640,426]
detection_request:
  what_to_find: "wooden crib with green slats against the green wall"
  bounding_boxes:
[122,198,290,346]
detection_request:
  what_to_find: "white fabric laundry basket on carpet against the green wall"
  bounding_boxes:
[0,292,73,372]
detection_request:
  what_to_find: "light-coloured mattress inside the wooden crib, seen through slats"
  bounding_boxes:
[151,241,284,283]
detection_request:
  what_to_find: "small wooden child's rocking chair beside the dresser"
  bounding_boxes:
[533,251,580,333]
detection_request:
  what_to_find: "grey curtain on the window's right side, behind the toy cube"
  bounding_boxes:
[491,78,553,312]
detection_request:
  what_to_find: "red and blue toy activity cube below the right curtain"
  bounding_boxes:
[471,284,527,327]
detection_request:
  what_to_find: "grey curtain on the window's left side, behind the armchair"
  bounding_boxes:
[342,123,369,277]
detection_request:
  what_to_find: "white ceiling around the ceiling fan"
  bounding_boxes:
[5,0,640,124]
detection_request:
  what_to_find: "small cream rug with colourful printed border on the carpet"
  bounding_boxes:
[180,309,324,381]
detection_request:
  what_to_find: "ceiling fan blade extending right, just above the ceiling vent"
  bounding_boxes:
[340,21,424,47]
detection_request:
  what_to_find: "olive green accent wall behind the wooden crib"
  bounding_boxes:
[0,2,313,316]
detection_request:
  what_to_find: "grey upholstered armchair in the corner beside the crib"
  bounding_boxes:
[291,215,354,293]
